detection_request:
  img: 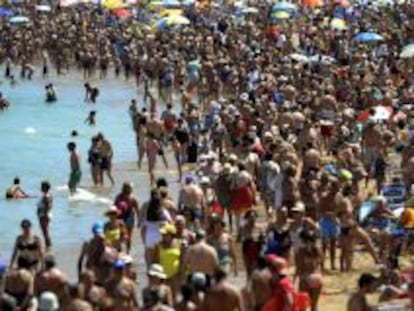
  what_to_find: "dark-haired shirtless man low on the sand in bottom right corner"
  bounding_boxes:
[347,273,378,311]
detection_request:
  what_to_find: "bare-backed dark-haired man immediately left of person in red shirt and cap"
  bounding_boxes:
[249,257,272,311]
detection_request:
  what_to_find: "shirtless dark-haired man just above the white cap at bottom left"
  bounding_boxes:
[35,255,67,299]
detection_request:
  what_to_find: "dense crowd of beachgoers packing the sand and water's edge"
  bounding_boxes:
[0,1,414,311]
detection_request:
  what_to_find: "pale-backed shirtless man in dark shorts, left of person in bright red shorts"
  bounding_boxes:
[178,176,207,226]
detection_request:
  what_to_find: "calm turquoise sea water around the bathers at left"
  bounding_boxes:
[0,70,141,256]
